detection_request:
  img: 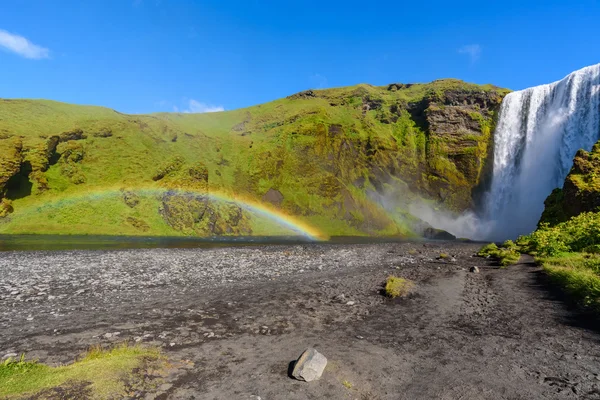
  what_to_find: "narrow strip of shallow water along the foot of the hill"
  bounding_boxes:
[0,235,414,251]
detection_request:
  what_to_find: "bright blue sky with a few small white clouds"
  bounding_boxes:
[0,0,600,113]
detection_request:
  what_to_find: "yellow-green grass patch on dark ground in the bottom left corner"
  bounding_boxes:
[0,344,161,399]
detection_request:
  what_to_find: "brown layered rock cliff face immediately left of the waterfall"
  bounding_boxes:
[412,84,503,211]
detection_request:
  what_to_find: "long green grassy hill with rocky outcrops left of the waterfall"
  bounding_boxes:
[0,80,507,236]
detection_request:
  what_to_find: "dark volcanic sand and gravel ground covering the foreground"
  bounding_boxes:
[0,242,600,400]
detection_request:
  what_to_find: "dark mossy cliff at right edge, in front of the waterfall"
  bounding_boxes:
[540,142,600,225]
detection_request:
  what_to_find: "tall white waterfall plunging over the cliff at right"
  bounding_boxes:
[482,64,600,240]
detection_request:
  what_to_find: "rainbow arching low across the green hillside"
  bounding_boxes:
[16,187,328,240]
